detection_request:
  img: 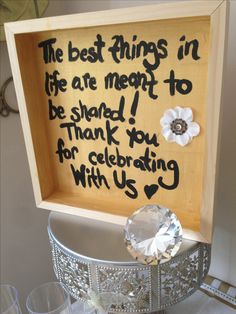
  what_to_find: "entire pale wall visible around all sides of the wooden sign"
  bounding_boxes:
[0,0,236,312]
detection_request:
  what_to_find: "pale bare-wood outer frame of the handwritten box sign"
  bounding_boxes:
[5,0,227,242]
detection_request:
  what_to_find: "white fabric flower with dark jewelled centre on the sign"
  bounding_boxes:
[160,106,200,146]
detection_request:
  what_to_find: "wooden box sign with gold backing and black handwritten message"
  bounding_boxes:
[5,1,227,242]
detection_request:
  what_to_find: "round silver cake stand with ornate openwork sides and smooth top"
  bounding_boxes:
[48,212,210,313]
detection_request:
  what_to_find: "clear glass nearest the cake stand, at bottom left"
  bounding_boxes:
[26,282,71,314]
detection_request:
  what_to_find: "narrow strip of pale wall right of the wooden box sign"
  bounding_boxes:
[211,1,236,286]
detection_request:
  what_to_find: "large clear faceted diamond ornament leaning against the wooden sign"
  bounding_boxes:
[125,205,183,265]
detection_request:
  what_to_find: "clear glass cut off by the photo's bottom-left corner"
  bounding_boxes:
[0,285,21,314]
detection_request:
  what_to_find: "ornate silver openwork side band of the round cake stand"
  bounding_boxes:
[49,231,211,313]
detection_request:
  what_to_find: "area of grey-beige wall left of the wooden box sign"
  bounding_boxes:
[0,43,54,312]
